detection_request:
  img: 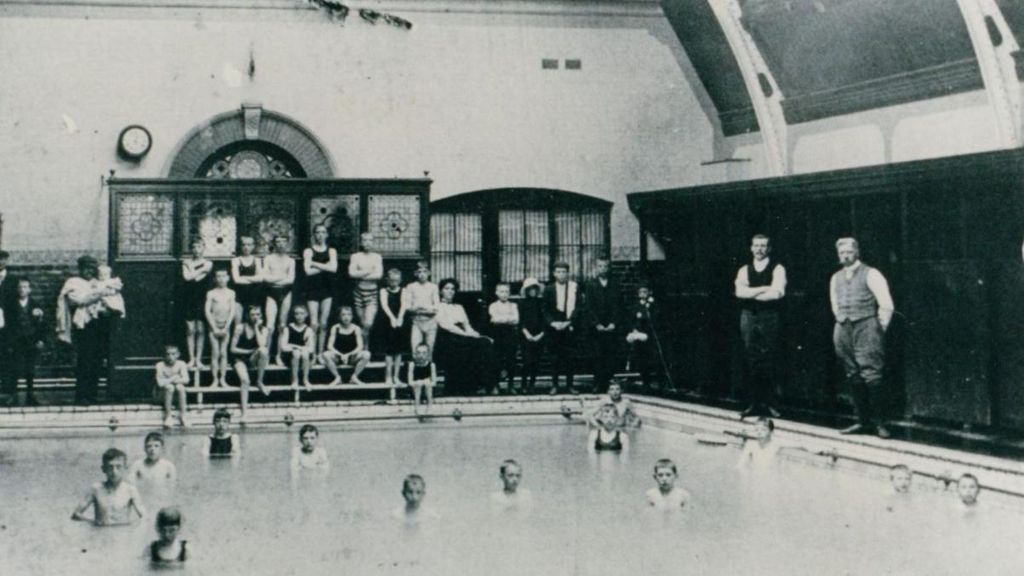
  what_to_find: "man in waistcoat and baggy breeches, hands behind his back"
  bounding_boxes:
[828,238,893,438]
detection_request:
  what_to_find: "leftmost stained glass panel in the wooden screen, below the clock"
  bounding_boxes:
[118,194,174,256]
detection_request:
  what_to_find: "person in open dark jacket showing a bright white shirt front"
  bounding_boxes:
[544,262,582,395]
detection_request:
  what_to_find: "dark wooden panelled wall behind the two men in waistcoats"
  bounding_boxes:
[630,146,1024,428]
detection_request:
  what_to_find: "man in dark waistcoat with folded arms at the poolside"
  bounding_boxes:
[735,234,786,418]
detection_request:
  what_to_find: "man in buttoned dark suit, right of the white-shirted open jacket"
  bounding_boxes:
[583,258,623,394]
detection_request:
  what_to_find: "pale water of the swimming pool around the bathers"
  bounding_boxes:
[0,416,1024,576]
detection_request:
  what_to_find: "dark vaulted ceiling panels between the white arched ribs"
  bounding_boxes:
[662,0,1024,135]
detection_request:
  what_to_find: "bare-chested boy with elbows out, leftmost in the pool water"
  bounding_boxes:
[71,448,145,526]
